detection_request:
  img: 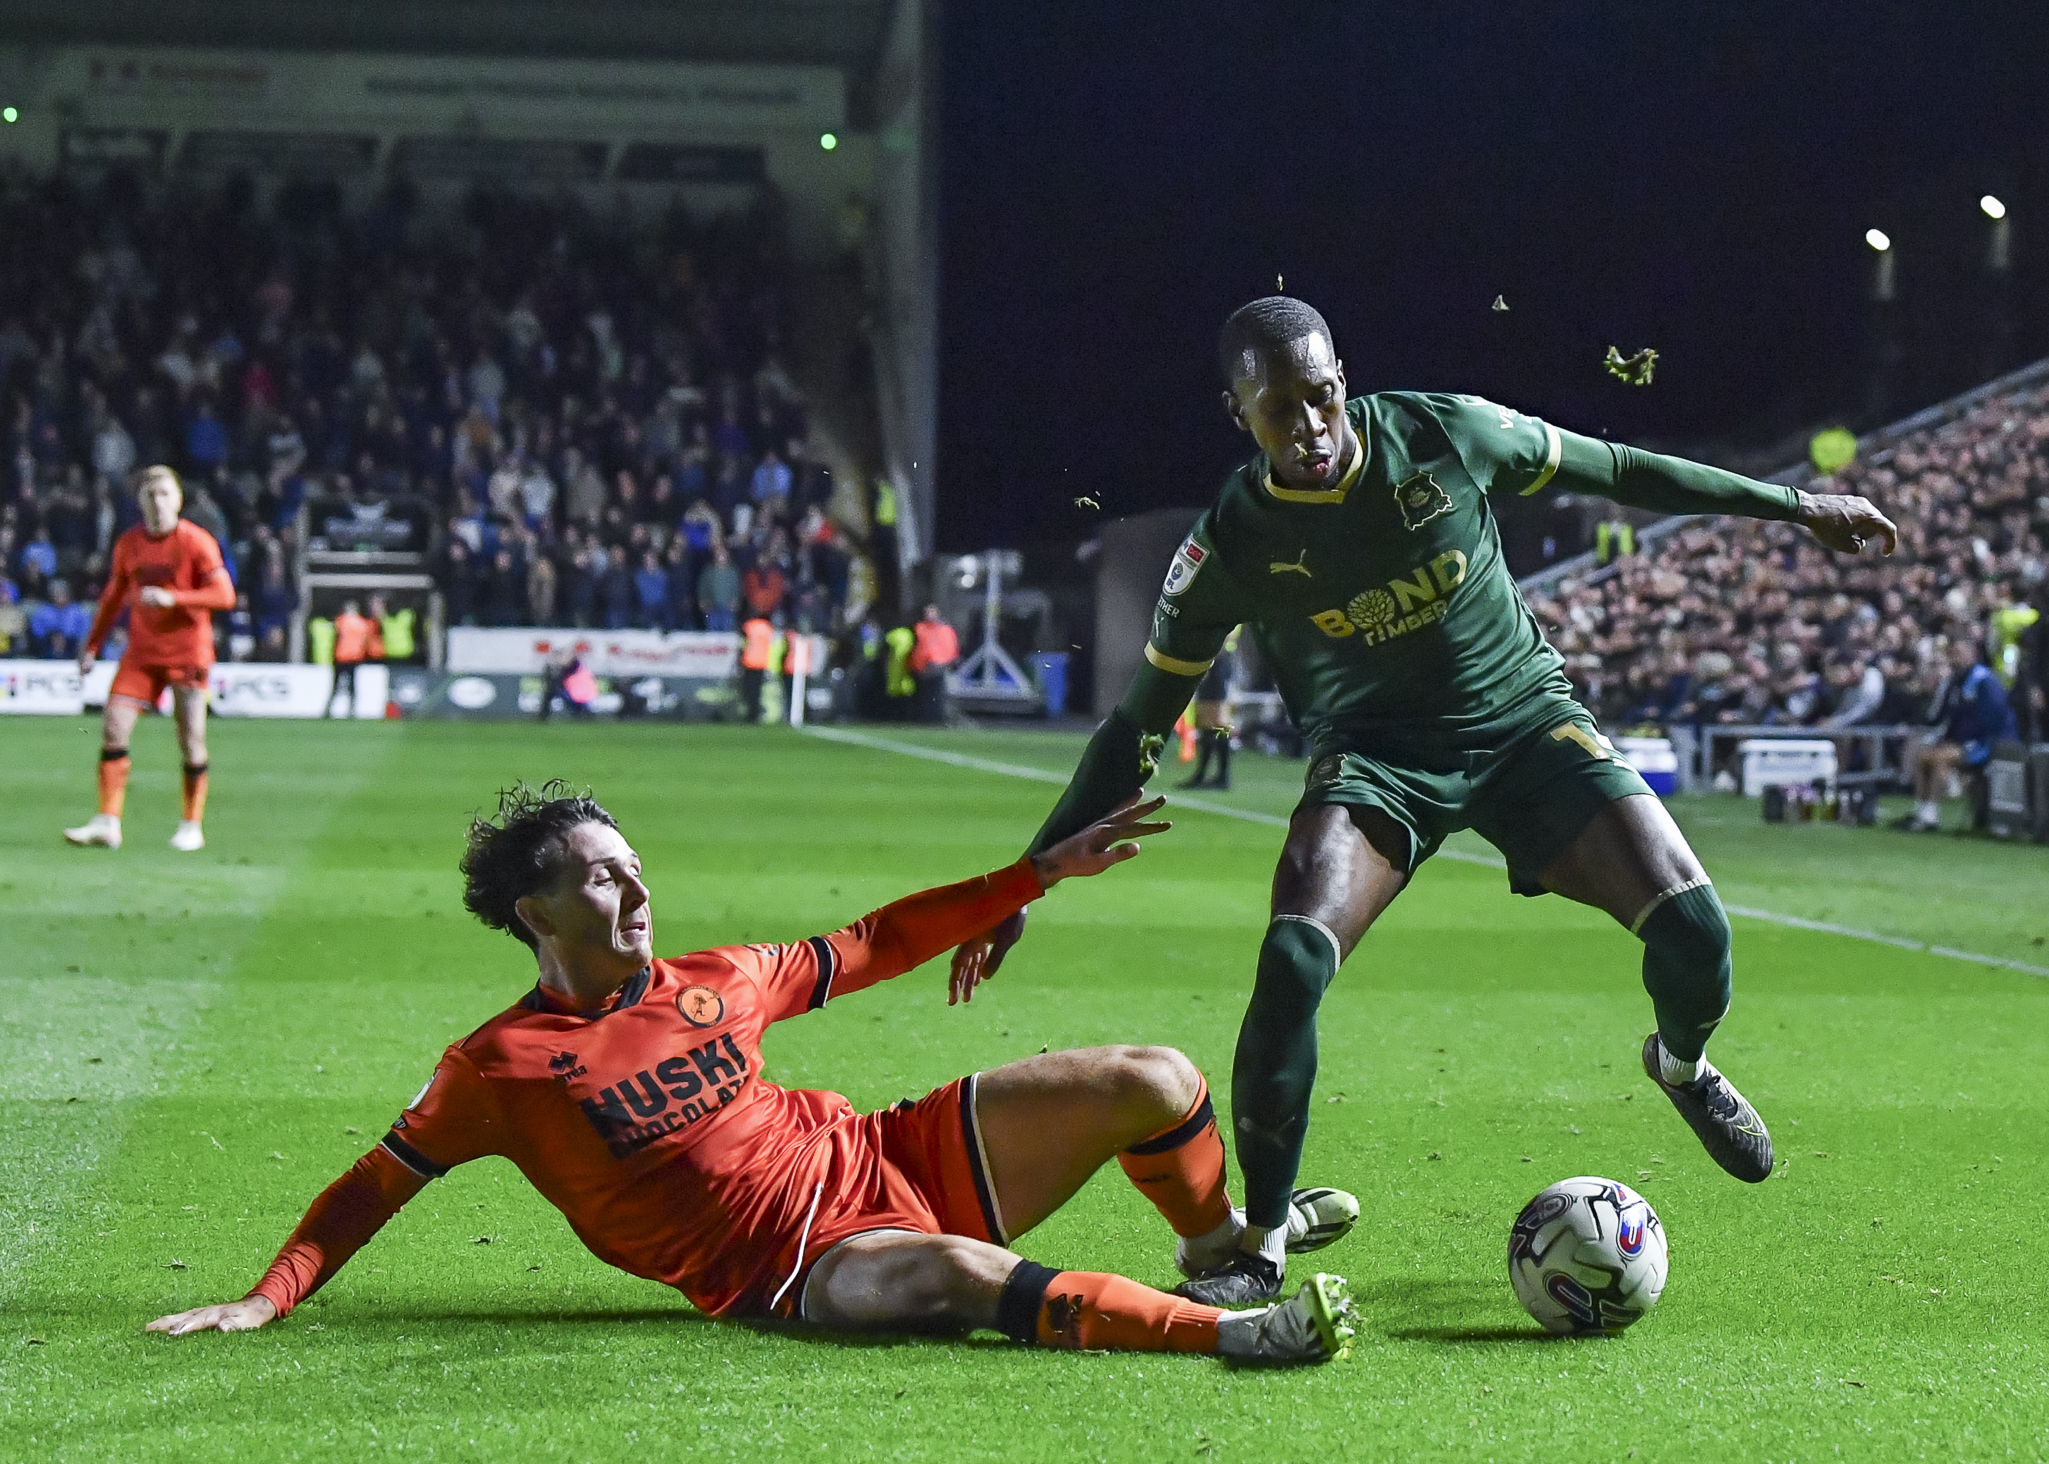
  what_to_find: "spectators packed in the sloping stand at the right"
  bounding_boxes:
[1531,385,2049,736]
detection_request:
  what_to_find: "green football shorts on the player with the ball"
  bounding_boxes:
[1301,703,1651,894]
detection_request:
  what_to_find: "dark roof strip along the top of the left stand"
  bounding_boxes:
[0,0,895,80]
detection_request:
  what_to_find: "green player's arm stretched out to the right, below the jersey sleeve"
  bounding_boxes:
[1555,433,1899,554]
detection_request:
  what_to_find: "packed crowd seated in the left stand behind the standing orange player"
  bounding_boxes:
[0,170,867,658]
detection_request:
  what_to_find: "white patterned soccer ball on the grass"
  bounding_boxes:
[1508,1177,1668,1337]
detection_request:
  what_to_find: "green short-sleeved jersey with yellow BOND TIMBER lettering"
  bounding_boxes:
[1145,392,1572,757]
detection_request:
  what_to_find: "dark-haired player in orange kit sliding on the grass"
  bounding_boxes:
[150,783,1350,1361]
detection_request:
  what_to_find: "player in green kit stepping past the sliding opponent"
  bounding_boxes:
[955,295,1895,1306]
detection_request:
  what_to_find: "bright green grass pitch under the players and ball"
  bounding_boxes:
[0,718,2049,1464]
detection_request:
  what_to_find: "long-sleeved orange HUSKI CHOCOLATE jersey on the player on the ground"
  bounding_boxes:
[252,859,1041,1314]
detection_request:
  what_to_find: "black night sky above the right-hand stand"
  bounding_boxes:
[938,0,2049,552]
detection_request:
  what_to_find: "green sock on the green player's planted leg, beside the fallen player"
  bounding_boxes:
[1231,914,1338,1230]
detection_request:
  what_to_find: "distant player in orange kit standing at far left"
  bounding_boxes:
[64,467,236,853]
